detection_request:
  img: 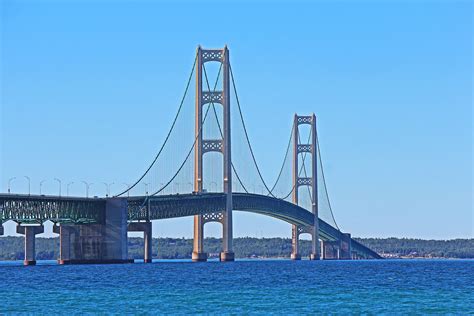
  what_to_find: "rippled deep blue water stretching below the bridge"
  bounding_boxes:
[0,260,474,314]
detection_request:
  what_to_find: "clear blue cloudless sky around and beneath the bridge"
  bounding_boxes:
[0,0,474,239]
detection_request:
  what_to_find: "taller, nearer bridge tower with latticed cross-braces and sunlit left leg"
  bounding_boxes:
[192,46,234,261]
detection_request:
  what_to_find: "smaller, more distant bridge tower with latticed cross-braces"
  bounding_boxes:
[291,113,319,260]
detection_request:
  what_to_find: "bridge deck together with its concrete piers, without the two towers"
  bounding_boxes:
[0,193,380,264]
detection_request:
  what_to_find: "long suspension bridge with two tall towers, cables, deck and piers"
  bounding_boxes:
[0,47,381,265]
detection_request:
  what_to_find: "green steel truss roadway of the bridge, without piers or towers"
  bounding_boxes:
[0,193,381,258]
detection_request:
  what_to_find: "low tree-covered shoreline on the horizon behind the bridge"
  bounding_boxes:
[0,236,474,260]
